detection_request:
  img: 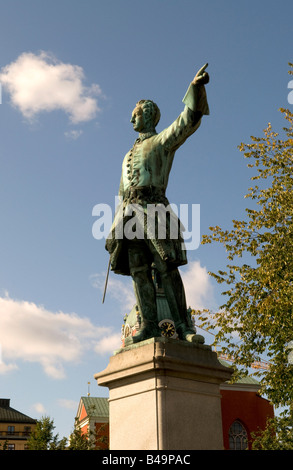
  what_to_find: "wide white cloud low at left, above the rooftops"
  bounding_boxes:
[0,296,111,379]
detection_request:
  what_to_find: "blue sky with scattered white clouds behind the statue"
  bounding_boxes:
[0,0,293,436]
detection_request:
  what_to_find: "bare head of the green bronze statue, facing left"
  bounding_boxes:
[130,100,161,132]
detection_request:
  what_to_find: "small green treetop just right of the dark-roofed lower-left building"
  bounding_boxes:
[27,416,67,450]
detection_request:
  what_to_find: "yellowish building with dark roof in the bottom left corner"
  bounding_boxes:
[0,398,37,450]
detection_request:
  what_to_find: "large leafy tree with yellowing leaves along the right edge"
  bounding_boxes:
[198,64,293,407]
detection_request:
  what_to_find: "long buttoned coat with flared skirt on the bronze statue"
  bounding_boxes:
[106,84,209,275]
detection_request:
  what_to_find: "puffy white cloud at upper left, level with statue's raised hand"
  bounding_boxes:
[0,51,101,124]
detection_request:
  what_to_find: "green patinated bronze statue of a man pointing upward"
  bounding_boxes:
[106,64,209,343]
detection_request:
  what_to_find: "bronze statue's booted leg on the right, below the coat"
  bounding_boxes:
[160,272,204,344]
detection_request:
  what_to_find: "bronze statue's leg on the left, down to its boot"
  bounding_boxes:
[126,241,161,344]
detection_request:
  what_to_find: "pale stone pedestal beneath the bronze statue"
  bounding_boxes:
[95,338,232,450]
